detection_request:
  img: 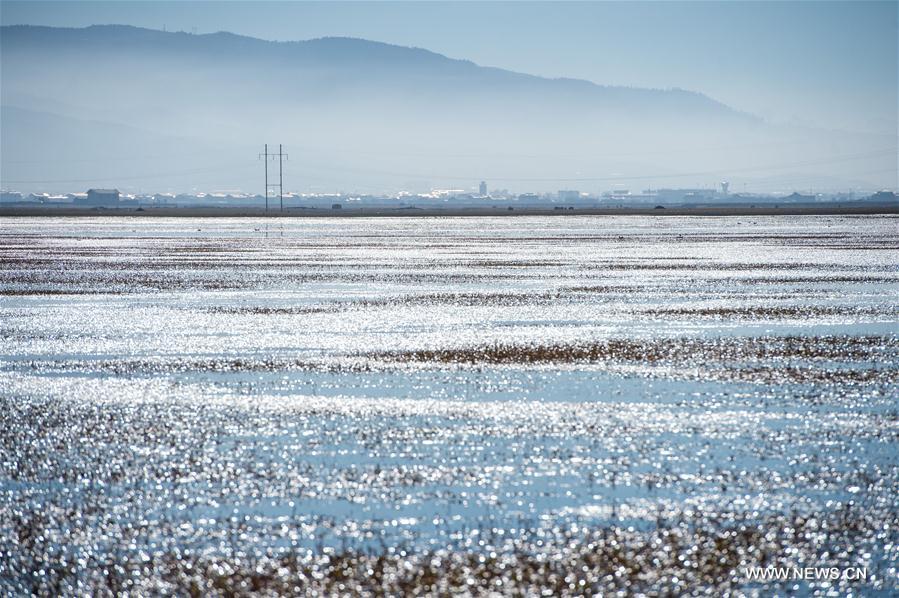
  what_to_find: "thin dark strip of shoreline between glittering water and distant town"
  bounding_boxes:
[0,204,899,218]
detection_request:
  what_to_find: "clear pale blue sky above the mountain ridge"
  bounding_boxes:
[0,0,899,133]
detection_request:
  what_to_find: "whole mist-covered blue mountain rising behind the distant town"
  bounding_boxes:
[0,26,896,192]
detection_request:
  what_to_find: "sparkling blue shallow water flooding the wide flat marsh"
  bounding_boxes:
[0,217,899,593]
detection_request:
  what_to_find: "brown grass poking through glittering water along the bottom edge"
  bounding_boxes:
[13,507,896,596]
